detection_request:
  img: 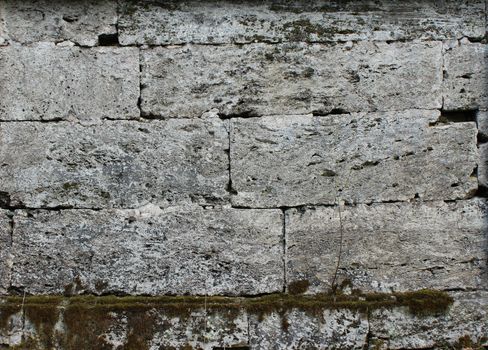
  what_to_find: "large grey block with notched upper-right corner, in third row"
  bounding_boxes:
[231,110,478,207]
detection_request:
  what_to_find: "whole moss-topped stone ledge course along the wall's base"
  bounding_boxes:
[0,290,488,350]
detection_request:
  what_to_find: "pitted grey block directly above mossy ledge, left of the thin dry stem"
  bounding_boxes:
[12,206,284,295]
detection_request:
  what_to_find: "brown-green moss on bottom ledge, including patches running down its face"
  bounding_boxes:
[0,290,453,349]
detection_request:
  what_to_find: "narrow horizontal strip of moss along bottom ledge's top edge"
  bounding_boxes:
[0,289,453,315]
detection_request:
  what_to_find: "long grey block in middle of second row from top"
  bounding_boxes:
[141,42,442,117]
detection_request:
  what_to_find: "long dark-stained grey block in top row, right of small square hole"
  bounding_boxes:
[119,0,485,45]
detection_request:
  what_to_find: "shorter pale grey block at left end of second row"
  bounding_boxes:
[0,43,139,120]
